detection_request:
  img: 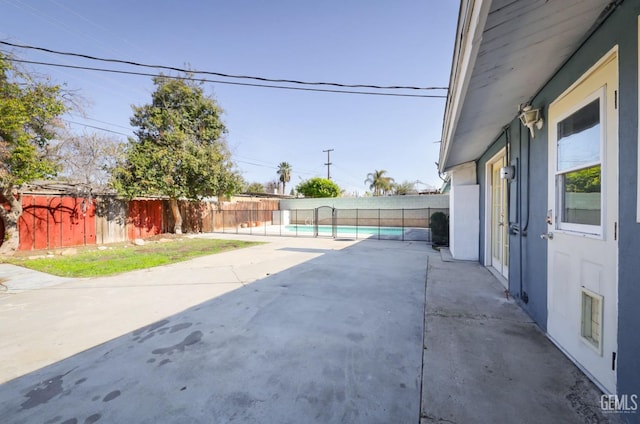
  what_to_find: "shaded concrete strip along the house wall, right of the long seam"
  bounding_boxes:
[421,252,620,424]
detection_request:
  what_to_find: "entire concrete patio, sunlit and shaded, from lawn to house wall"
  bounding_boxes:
[0,235,615,424]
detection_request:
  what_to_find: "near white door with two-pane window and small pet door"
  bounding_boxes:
[543,50,618,393]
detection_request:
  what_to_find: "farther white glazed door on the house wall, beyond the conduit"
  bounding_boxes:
[490,156,509,282]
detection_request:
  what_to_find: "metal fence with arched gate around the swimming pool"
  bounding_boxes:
[212,206,449,242]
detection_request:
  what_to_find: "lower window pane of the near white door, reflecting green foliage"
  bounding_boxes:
[560,165,602,225]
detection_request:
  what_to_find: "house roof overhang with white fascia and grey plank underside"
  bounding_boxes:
[438,0,620,172]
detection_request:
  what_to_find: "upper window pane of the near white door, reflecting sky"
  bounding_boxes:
[558,98,600,171]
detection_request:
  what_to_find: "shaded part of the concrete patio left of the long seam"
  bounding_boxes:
[0,242,430,424]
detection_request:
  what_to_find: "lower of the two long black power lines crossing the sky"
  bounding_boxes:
[10,58,447,99]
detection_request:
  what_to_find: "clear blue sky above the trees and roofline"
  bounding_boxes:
[0,0,459,195]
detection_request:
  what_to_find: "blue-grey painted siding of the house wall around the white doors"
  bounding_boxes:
[478,0,640,400]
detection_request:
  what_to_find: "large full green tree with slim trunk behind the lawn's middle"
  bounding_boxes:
[113,75,241,234]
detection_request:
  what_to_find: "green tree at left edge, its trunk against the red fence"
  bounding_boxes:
[0,53,67,254]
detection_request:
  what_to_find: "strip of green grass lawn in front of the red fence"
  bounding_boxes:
[2,237,261,277]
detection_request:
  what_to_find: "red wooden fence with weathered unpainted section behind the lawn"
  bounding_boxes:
[0,194,278,250]
